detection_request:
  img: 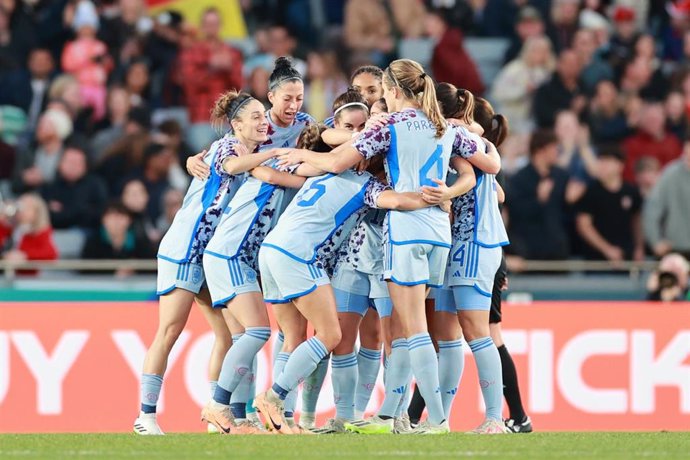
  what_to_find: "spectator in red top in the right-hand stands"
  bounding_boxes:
[623,102,683,182]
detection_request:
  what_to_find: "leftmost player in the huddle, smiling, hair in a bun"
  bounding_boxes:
[134,92,273,434]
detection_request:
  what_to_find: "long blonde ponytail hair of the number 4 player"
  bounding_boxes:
[383,59,447,137]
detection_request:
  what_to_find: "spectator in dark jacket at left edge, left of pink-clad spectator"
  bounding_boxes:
[0,48,55,131]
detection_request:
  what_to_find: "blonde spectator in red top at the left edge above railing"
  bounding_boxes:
[0,193,58,274]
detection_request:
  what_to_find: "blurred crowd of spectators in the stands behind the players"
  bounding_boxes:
[0,0,690,294]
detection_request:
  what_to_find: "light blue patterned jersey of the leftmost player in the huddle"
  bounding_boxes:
[158,133,244,264]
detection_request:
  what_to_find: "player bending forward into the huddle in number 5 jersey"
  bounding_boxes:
[255,126,440,434]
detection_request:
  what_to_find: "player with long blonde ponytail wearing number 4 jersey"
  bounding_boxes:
[274,59,484,434]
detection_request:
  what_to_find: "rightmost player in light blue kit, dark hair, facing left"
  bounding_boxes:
[434,83,508,434]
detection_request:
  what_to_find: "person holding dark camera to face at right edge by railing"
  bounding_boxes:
[647,253,690,302]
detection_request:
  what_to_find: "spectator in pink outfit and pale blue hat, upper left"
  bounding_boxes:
[62,0,112,120]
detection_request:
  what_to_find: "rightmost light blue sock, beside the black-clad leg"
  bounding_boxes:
[469,337,503,422]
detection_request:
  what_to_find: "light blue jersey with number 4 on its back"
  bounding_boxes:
[354,109,477,248]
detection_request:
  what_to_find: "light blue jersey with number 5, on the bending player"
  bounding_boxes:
[263,170,387,264]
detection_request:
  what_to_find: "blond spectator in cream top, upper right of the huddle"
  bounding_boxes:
[491,35,556,134]
